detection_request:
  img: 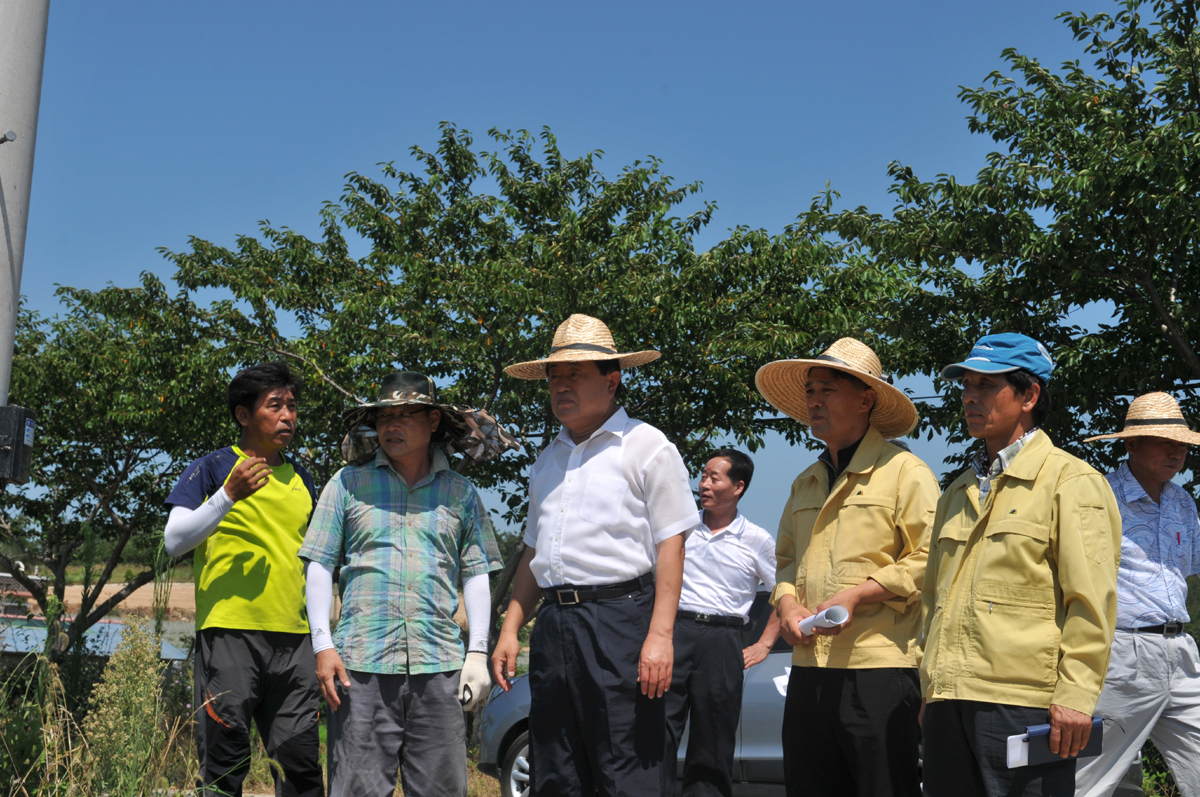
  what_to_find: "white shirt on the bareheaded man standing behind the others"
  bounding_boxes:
[679,513,775,619]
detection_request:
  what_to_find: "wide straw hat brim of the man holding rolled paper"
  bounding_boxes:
[754,360,919,437]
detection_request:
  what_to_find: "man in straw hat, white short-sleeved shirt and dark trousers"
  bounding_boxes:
[492,314,700,797]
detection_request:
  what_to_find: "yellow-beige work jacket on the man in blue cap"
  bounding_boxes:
[920,431,1121,714]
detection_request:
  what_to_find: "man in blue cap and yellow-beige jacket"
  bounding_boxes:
[920,334,1121,797]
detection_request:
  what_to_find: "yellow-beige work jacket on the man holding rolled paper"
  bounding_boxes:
[770,426,938,669]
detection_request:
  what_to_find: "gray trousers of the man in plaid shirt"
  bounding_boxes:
[328,670,467,797]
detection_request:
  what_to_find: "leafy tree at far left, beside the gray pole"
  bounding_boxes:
[0,281,230,658]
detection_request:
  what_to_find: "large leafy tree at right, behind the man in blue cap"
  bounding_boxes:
[824,0,1200,480]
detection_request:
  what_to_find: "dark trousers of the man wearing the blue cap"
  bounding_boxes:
[924,700,1075,797]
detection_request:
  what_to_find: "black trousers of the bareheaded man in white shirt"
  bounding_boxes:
[662,618,744,797]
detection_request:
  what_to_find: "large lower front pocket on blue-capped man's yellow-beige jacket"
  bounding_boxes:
[966,580,1060,689]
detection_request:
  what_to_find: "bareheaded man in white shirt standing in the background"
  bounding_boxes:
[662,449,779,797]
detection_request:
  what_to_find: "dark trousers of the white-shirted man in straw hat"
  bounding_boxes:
[529,586,666,797]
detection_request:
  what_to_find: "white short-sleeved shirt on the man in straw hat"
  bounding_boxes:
[524,408,700,588]
